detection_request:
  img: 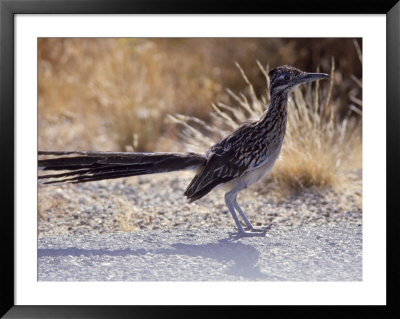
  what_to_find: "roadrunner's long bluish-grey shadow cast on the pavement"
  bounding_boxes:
[38,234,279,281]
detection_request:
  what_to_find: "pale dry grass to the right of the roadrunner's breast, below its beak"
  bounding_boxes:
[273,60,362,192]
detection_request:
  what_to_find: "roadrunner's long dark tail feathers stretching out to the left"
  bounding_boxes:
[38,151,206,184]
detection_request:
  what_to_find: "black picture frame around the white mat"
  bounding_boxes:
[0,0,400,318]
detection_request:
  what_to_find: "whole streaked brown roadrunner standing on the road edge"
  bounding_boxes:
[38,65,329,236]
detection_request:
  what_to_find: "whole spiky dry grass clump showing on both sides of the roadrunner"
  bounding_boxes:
[170,60,362,197]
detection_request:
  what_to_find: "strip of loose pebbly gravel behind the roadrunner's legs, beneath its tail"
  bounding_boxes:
[38,172,362,238]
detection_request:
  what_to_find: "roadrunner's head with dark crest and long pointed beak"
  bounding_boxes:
[268,65,329,95]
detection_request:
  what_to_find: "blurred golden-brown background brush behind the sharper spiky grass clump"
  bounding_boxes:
[38,38,362,151]
